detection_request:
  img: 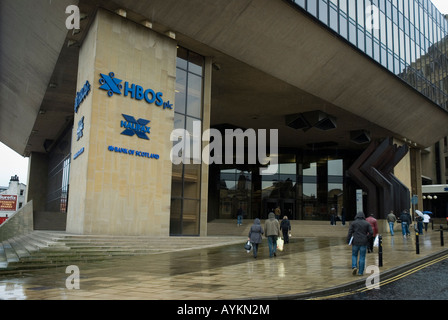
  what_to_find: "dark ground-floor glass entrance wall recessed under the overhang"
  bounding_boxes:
[218,150,345,220]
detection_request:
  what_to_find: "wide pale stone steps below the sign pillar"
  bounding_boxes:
[0,230,244,275]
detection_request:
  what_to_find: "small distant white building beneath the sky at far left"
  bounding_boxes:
[0,175,26,218]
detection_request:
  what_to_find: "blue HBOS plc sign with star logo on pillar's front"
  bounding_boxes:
[99,72,173,109]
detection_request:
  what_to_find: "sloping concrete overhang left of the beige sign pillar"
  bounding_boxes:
[0,0,77,155]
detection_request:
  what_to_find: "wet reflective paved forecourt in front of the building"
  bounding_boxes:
[0,230,448,300]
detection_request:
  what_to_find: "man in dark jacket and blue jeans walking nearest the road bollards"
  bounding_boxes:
[347,212,373,276]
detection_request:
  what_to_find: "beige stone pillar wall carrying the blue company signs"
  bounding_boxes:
[67,10,176,236]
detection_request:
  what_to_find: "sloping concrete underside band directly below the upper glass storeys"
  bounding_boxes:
[115,0,448,147]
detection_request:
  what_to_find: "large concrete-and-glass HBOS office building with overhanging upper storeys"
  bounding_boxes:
[0,0,448,236]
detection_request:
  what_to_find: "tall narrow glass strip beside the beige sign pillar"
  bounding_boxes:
[170,47,204,235]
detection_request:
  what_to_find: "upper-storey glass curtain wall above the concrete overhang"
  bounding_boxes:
[287,0,448,110]
